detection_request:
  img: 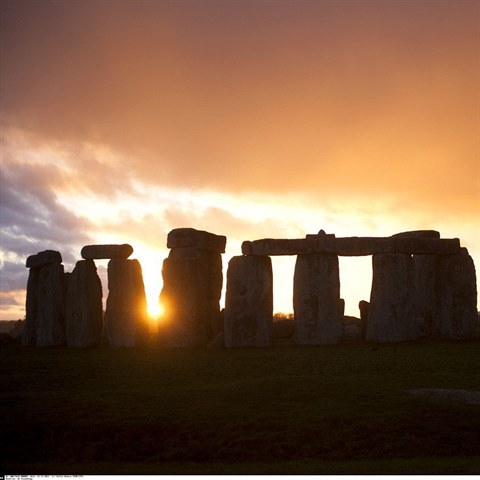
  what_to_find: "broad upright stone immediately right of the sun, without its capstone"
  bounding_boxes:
[160,247,223,347]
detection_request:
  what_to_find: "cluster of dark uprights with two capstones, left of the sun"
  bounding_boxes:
[22,244,148,348]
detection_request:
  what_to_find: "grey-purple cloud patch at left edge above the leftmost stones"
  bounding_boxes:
[0,159,97,315]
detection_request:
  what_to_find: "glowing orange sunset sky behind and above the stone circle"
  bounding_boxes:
[0,0,480,320]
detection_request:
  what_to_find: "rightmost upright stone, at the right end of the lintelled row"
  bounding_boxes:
[433,248,478,339]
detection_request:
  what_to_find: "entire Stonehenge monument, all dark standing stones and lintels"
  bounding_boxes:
[22,228,478,348]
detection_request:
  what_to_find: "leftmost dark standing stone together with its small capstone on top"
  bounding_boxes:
[22,250,65,347]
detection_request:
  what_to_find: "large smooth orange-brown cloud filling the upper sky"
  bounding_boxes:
[2,0,479,211]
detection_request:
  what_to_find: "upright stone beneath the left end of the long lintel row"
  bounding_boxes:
[224,257,273,348]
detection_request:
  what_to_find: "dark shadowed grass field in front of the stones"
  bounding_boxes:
[0,342,480,474]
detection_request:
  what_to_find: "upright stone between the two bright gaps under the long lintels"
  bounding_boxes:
[293,254,342,345]
